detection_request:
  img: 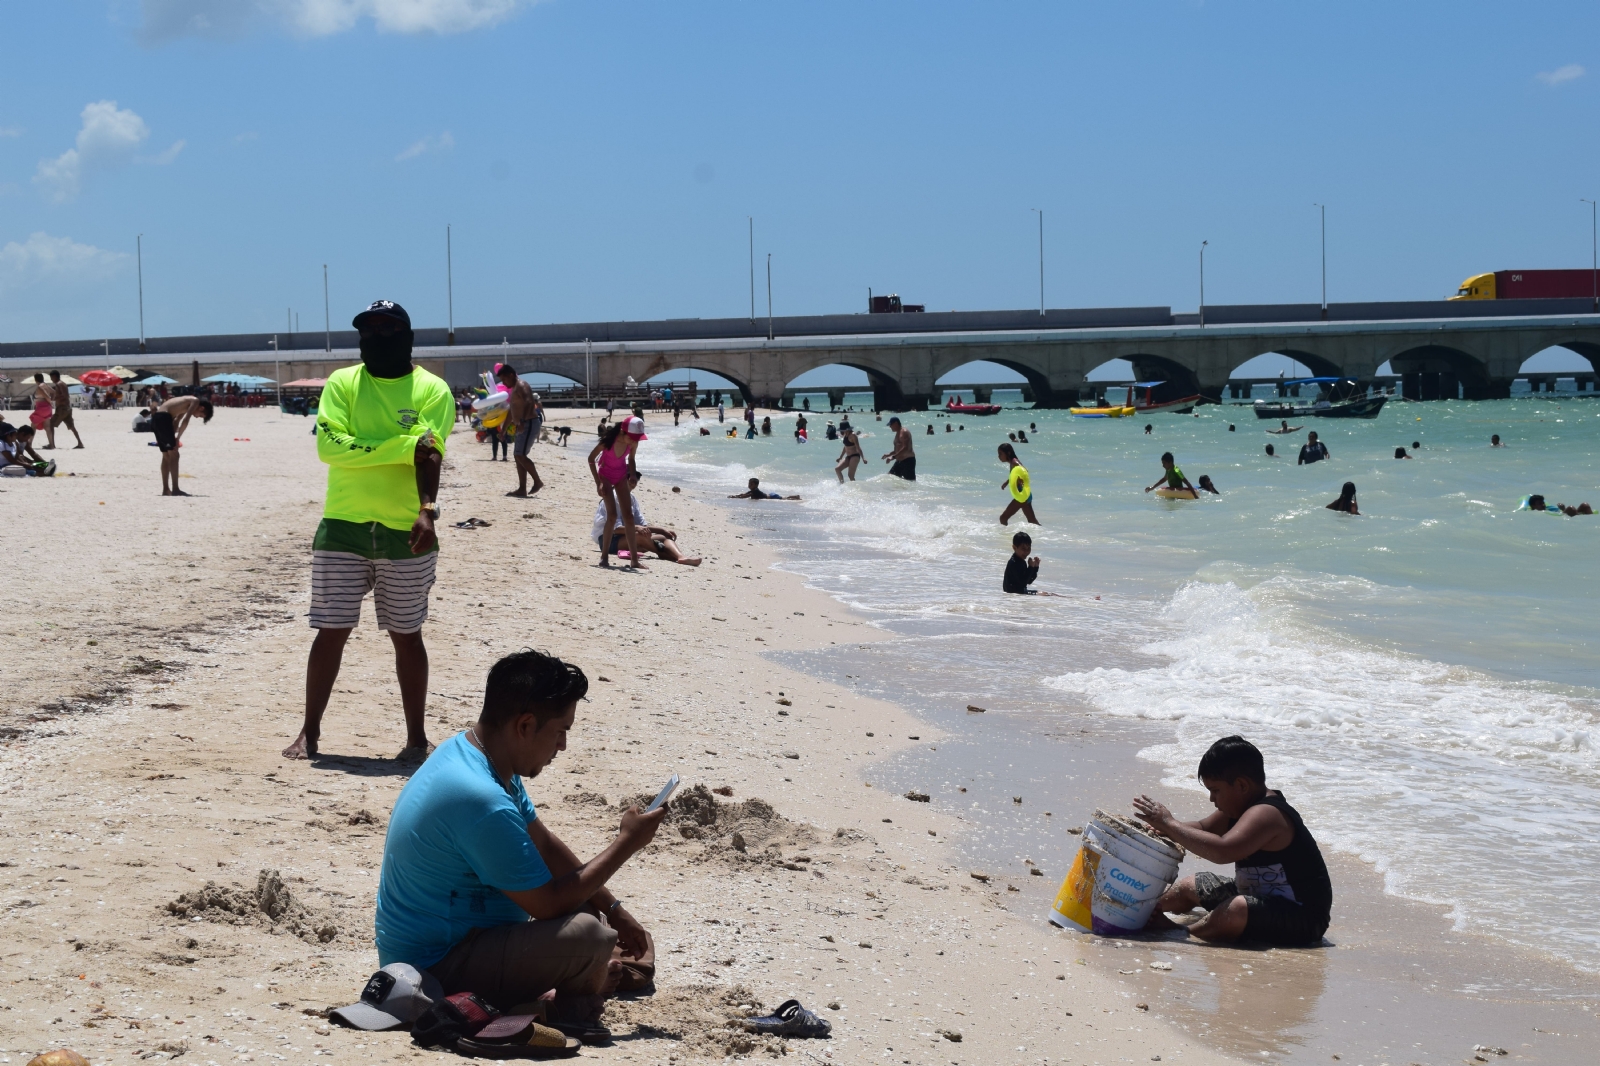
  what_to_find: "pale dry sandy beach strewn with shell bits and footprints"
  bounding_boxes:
[0,410,1254,1064]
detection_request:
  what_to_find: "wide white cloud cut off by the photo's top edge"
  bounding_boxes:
[139,0,536,43]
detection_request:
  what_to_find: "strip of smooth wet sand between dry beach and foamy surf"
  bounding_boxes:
[646,415,1600,1063]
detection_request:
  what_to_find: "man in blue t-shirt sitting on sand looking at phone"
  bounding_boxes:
[373,650,667,1024]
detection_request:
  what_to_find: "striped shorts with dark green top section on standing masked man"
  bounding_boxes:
[310,519,438,632]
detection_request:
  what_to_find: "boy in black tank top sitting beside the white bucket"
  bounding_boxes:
[1133,736,1333,946]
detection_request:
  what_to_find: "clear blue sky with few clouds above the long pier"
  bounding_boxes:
[0,0,1600,376]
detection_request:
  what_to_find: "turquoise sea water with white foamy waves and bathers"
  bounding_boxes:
[642,394,1600,972]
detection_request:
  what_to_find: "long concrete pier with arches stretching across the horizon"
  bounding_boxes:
[0,299,1600,410]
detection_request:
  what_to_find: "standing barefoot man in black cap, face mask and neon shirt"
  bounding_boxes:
[283,299,456,759]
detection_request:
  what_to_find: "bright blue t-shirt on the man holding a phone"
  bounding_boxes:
[374,733,550,970]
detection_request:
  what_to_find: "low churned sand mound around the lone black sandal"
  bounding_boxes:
[605,979,789,1058]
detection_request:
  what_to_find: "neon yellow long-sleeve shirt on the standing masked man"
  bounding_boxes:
[317,365,456,530]
